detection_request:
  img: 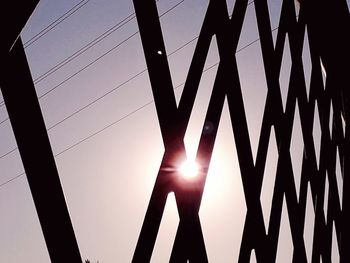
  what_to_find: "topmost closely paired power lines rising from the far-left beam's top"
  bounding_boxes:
[23,0,90,49]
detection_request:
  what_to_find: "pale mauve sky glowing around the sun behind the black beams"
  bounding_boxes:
[0,0,349,263]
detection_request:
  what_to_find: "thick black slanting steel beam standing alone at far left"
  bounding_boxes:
[0,38,82,263]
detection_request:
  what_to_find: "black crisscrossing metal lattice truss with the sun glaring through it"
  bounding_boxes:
[133,0,350,263]
